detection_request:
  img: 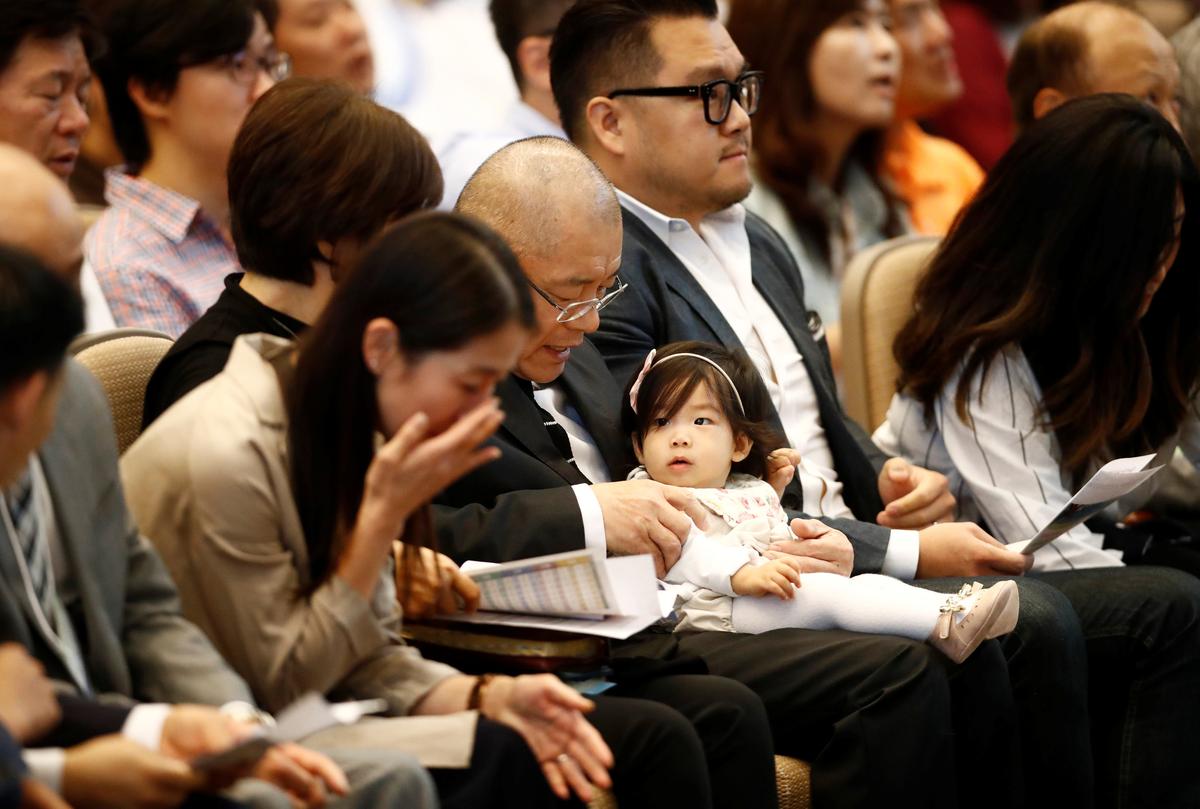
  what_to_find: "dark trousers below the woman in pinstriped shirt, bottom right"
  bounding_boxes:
[919,567,1200,809]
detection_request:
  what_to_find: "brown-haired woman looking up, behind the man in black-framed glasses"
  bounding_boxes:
[728,0,910,367]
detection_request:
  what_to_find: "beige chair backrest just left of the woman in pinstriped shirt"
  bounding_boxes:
[841,236,941,432]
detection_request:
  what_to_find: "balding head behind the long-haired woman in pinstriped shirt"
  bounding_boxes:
[1008,0,1180,128]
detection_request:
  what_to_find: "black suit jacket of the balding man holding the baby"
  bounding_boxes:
[433,340,632,562]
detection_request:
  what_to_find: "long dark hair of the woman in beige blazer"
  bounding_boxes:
[284,212,534,592]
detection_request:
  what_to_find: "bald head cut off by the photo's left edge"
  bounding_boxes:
[0,144,83,283]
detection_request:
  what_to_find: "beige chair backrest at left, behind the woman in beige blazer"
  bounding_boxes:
[71,329,173,453]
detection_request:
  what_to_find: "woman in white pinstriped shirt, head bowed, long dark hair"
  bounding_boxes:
[875,95,1200,570]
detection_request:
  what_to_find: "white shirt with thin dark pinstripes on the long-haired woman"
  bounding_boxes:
[874,346,1152,570]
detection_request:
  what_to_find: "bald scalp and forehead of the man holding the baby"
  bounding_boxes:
[455,138,620,258]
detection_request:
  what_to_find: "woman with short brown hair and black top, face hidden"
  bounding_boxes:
[143,78,442,425]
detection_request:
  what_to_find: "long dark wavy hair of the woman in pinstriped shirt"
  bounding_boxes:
[895,95,1200,479]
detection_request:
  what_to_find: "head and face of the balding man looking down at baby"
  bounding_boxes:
[456,138,622,384]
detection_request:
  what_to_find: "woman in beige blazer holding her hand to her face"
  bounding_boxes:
[122,212,769,809]
